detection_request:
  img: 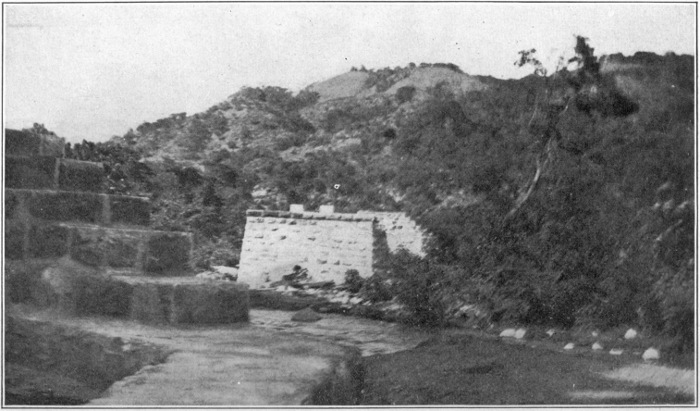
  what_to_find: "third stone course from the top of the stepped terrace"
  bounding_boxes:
[5,189,150,227]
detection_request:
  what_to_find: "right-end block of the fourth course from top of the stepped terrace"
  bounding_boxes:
[144,232,192,275]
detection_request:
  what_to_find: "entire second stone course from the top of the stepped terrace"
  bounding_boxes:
[5,156,105,193]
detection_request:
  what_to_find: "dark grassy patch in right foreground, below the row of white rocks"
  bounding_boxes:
[362,335,693,405]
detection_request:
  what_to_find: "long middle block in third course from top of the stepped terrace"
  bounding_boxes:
[24,191,104,224]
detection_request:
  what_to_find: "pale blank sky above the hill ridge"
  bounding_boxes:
[2,2,697,142]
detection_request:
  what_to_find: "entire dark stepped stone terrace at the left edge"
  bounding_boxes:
[4,129,249,323]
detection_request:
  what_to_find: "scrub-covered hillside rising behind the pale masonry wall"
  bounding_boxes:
[61,45,695,348]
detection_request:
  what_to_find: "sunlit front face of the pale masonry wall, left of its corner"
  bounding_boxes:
[238,210,374,288]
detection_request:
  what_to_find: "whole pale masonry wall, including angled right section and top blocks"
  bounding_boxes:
[239,204,425,288]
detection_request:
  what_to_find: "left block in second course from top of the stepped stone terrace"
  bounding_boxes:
[5,156,57,189]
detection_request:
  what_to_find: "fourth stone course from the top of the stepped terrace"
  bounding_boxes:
[5,222,192,276]
